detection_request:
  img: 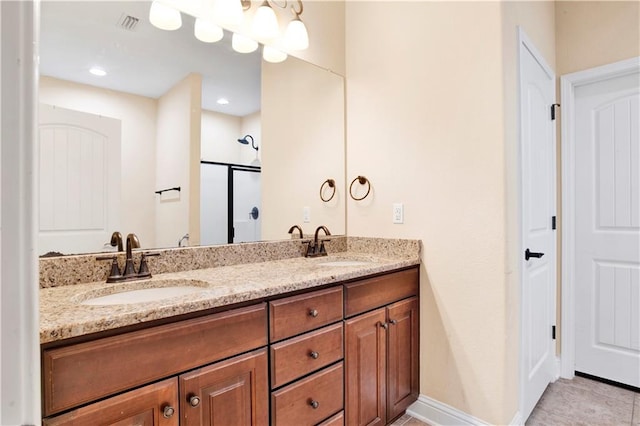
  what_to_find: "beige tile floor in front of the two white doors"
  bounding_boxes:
[526,377,640,426]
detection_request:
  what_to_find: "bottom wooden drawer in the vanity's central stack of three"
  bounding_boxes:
[271,362,344,426]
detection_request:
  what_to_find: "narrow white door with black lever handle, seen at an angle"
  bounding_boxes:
[520,33,556,419]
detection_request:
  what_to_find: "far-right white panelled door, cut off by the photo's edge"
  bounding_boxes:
[574,71,640,387]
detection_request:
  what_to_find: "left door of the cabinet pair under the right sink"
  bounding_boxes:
[345,308,387,426]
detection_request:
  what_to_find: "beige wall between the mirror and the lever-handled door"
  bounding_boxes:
[346,2,555,424]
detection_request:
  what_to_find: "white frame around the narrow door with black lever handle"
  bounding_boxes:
[517,26,559,422]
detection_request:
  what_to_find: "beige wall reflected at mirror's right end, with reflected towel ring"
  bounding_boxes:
[262,58,345,239]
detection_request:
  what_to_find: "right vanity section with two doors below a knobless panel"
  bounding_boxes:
[345,268,419,426]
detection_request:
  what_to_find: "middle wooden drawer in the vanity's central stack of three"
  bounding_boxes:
[271,322,343,388]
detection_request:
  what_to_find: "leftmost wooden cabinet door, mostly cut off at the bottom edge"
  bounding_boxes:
[42,378,179,426]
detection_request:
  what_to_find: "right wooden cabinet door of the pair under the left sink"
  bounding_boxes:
[180,349,269,426]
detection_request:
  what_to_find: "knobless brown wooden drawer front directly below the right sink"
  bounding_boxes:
[344,268,420,317]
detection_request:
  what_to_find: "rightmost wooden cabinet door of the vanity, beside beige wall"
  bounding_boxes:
[387,297,420,420]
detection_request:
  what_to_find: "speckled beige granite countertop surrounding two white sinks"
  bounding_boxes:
[40,251,420,343]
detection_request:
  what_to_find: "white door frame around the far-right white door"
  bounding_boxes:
[560,57,640,379]
